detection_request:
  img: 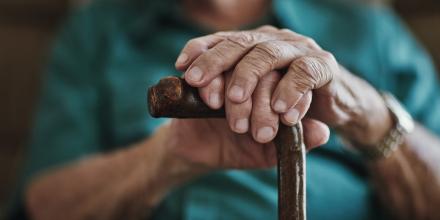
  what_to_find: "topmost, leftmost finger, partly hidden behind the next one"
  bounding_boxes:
[175,35,224,71]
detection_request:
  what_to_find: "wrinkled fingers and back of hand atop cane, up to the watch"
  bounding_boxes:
[176,26,391,148]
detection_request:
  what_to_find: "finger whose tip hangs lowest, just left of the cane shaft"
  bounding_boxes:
[251,71,281,143]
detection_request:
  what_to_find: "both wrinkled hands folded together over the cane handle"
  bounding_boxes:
[167,26,389,168]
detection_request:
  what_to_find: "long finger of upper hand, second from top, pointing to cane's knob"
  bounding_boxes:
[185,31,271,87]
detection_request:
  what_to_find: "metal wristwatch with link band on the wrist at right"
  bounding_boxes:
[358,92,414,160]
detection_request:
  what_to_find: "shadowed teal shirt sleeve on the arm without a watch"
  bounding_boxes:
[11,5,102,219]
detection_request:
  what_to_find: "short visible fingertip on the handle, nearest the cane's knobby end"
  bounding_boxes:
[199,75,225,109]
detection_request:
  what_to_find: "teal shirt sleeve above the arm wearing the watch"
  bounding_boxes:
[376,8,440,135]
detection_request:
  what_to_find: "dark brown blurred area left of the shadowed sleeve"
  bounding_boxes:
[0,0,69,219]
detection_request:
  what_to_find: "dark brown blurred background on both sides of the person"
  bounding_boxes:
[0,0,440,219]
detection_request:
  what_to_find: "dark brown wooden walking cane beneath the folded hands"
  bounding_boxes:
[148,77,306,220]
